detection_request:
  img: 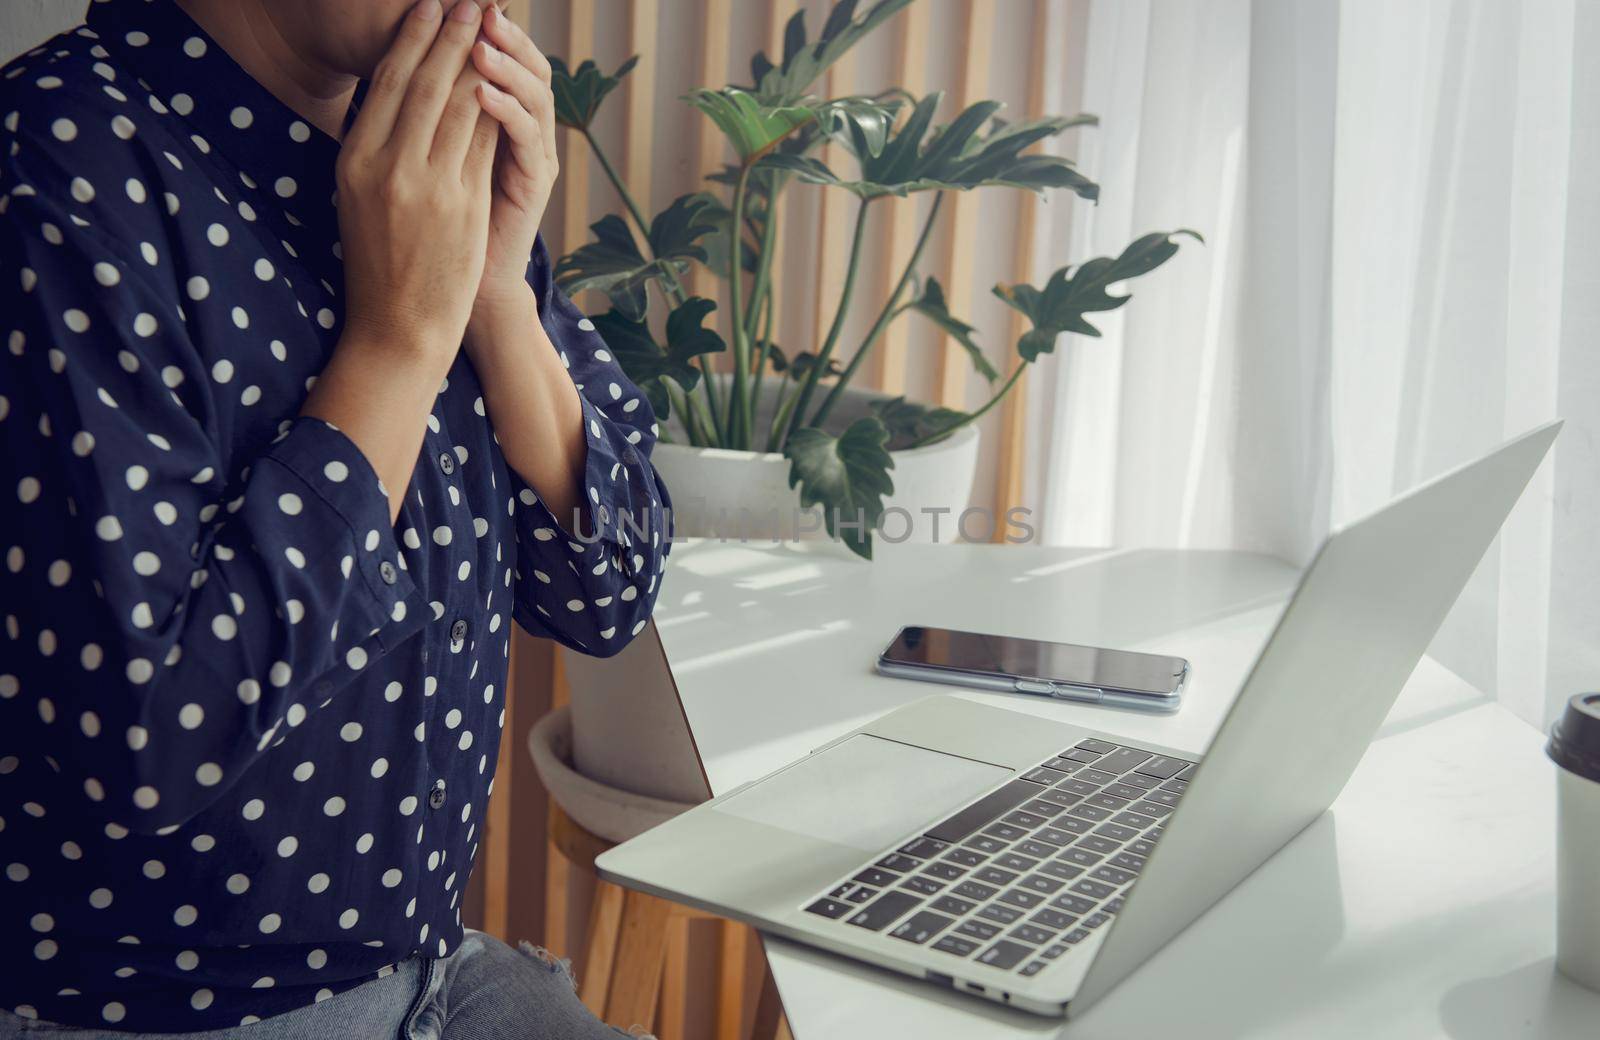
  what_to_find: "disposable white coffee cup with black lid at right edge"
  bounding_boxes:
[1544,693,1600,992]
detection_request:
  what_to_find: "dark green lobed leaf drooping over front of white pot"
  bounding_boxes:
[784,416,894,560]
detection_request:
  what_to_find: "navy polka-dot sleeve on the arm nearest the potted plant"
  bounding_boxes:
[510,237,670,658]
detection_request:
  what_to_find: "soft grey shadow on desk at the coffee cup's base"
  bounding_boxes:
[1438,957,1600,1040]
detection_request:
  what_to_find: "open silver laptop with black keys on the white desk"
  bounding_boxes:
[595,422,1560,1016]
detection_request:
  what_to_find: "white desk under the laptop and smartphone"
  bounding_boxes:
[656,542,1600,1040]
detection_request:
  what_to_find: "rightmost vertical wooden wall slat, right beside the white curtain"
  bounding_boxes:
[994,0,1066,542]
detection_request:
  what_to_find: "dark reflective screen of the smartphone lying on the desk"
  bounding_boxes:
[883,627,1186,694]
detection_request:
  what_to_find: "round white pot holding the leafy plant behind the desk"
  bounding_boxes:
[650,379,978,550]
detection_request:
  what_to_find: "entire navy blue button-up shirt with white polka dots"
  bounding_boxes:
[0,0,667,1032]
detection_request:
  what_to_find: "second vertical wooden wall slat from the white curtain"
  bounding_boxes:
[936,0,997,408]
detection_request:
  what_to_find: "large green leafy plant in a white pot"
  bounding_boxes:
[550,0,1198,558]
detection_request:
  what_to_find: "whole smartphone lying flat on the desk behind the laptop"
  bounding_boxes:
[878,626,1189,712]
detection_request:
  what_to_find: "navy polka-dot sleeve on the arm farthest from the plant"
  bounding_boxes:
[0,178,427,834]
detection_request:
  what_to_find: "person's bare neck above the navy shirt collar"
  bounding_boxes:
[176,0,357,139]
